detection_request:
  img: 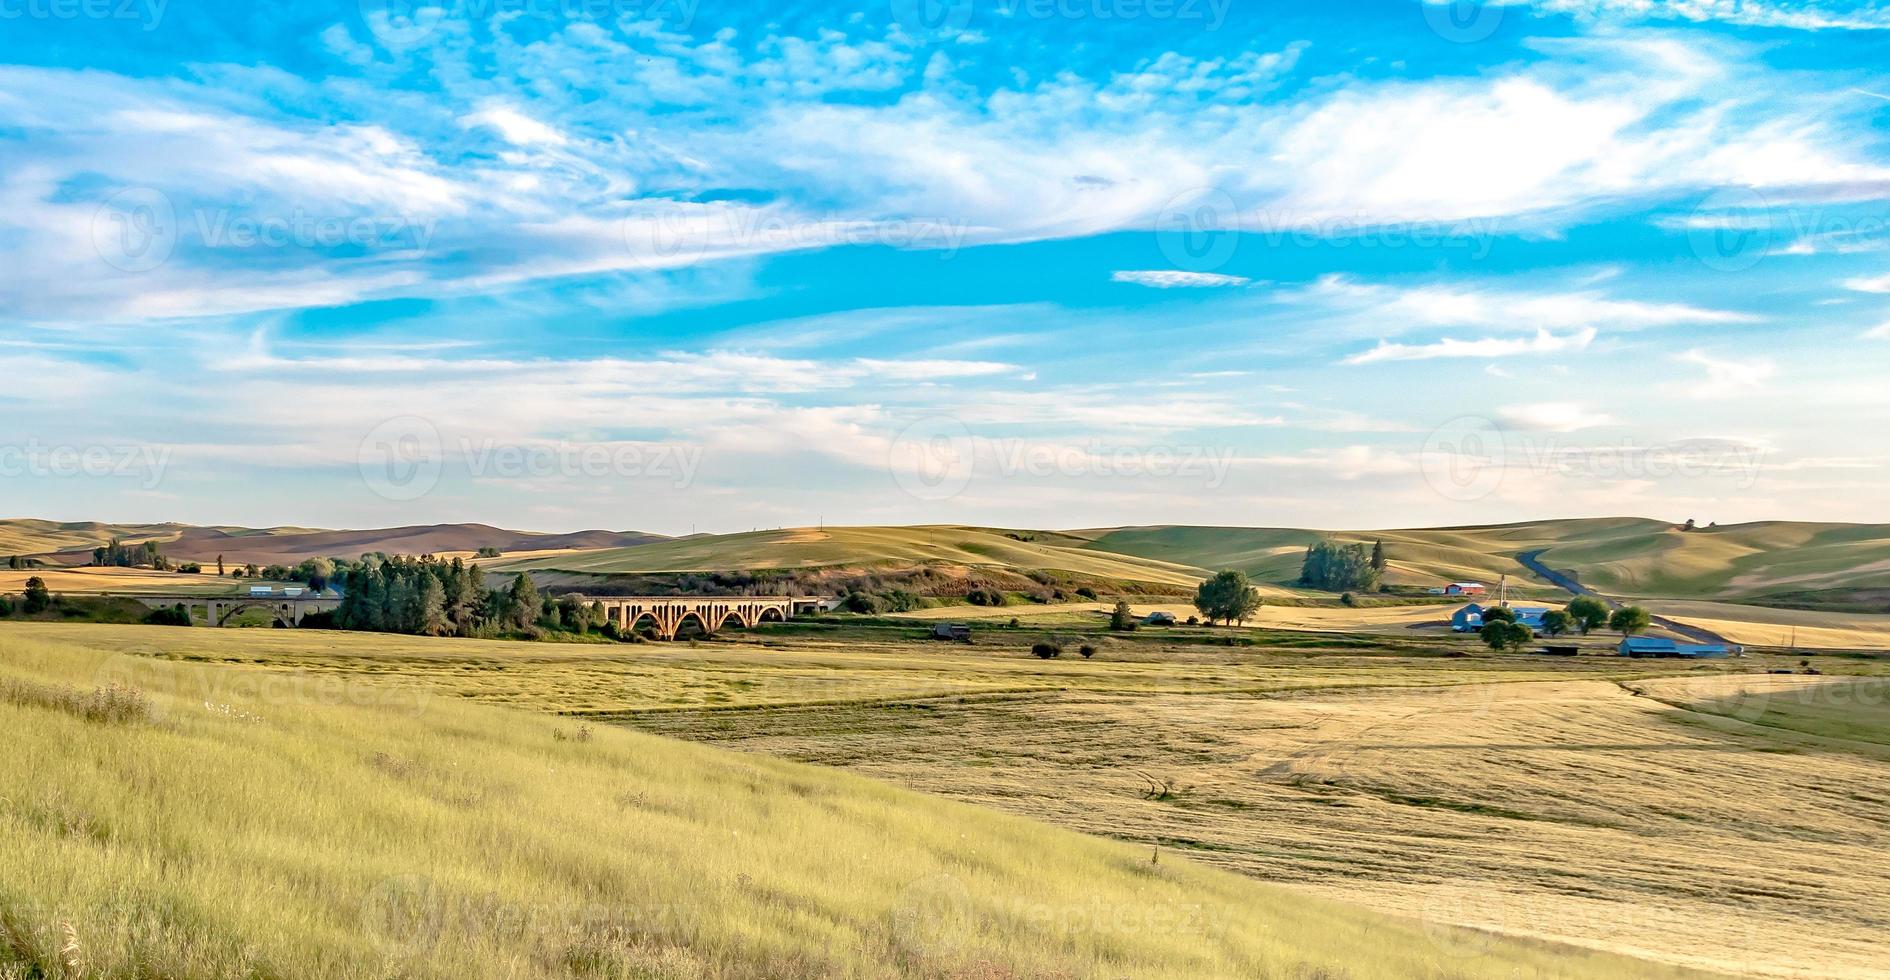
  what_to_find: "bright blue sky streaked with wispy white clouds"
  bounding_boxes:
[0,0,1890,532]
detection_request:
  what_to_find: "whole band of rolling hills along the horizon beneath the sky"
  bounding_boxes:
[14,517,1890,612]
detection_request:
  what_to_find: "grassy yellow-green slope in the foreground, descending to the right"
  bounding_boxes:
[0,633,1686,980]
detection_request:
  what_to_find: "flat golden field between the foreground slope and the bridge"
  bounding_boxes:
[11,625,1890,978]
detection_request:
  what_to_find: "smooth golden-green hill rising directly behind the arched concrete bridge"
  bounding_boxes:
[493,525,1206,587]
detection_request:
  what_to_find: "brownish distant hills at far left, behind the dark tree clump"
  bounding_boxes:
[0,519,667,565]
